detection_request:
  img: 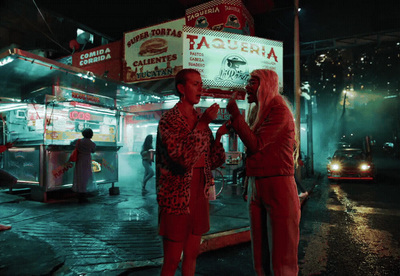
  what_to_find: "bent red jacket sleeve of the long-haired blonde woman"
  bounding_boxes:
[232,106,288,153]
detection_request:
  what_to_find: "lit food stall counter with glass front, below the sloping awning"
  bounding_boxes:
[1,86,121,200]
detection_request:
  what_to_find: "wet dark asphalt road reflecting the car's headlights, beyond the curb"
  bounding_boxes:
[126,155,400,276]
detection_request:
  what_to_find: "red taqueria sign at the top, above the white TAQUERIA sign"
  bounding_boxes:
[185,0,254,36]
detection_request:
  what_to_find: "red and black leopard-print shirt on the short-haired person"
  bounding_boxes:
[156,105,225,215]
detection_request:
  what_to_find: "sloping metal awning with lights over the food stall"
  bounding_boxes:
[0,48,147,106]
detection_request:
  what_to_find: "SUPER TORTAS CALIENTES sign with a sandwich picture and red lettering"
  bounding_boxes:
[123,18,185,83]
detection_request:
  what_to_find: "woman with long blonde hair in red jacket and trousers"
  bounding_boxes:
[227,69,300,276]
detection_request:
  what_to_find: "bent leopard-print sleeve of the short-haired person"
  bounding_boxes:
[159,115,209,170]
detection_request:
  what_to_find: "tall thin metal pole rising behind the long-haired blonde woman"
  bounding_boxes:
[294,0,301,180]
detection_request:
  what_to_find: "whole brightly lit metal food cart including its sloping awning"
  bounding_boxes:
[0,49,123,201]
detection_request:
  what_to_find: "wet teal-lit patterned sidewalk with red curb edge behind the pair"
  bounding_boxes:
[0,167,313,275]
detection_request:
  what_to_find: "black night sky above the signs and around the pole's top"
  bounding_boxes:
[36,0,400,42]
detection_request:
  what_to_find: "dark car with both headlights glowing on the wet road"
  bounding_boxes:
[327,148,376,181]
